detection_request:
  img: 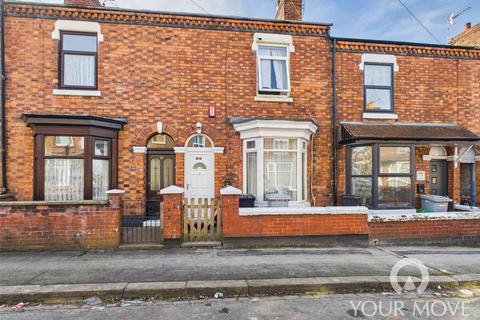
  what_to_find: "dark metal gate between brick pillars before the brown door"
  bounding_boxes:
[122,200,163,244]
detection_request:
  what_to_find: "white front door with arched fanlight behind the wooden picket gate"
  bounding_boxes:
[185,134,215,199]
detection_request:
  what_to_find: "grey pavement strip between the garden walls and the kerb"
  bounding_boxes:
[0,247,480,286]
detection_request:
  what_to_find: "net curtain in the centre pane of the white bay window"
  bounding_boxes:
[264,151,297,201]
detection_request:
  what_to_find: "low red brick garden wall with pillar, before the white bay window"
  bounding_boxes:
[222,196,368,238]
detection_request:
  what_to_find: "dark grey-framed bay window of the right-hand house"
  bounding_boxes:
[347,144,414,209]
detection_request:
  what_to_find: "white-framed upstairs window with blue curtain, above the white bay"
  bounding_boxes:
[257,45,290,95]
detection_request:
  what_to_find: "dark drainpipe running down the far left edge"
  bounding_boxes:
[0,0,8,193]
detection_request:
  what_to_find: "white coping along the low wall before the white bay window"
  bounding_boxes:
[238,207,368,216]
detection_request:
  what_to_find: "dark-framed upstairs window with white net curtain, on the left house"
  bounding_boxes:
[59,32,97,89]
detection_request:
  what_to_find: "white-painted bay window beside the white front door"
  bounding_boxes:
[231,118,318,206]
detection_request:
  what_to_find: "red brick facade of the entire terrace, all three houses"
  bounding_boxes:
[5,1,480,214]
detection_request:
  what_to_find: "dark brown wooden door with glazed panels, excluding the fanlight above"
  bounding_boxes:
[145,154,175,216]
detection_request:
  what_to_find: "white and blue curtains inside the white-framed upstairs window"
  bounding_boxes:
[259,47,288,89]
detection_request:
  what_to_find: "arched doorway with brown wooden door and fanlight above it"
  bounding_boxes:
[145,134,175,216]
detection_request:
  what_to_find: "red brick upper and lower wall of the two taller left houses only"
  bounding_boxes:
[5,3,332,205]
